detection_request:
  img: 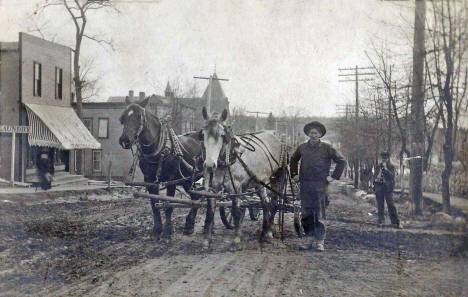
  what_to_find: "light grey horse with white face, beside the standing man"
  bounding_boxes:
[200,108,286,248]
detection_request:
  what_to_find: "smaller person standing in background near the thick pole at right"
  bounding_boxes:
[374,152,402,229]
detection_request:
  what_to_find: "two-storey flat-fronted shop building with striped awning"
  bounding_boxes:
[0,33,100,181]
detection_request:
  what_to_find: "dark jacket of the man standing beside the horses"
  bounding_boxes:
[290,141,346,183]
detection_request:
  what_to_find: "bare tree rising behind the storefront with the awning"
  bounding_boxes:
[34,0,119,116]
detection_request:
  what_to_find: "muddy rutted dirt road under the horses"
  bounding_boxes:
[0,185,468,296]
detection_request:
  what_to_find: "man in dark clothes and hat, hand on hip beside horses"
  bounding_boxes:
[290,122,346,251]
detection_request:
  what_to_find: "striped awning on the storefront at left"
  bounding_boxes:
[24,103,101,150]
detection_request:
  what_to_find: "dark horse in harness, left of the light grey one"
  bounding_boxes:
[119,97,204,239]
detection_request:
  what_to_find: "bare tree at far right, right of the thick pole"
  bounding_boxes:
[425,0,468,213]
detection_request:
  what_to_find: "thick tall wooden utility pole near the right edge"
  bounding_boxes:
[410,0,426,215]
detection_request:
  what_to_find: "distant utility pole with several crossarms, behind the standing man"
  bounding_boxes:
[338,65,375,189]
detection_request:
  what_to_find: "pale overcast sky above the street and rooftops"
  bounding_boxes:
[0,0,414,116]
